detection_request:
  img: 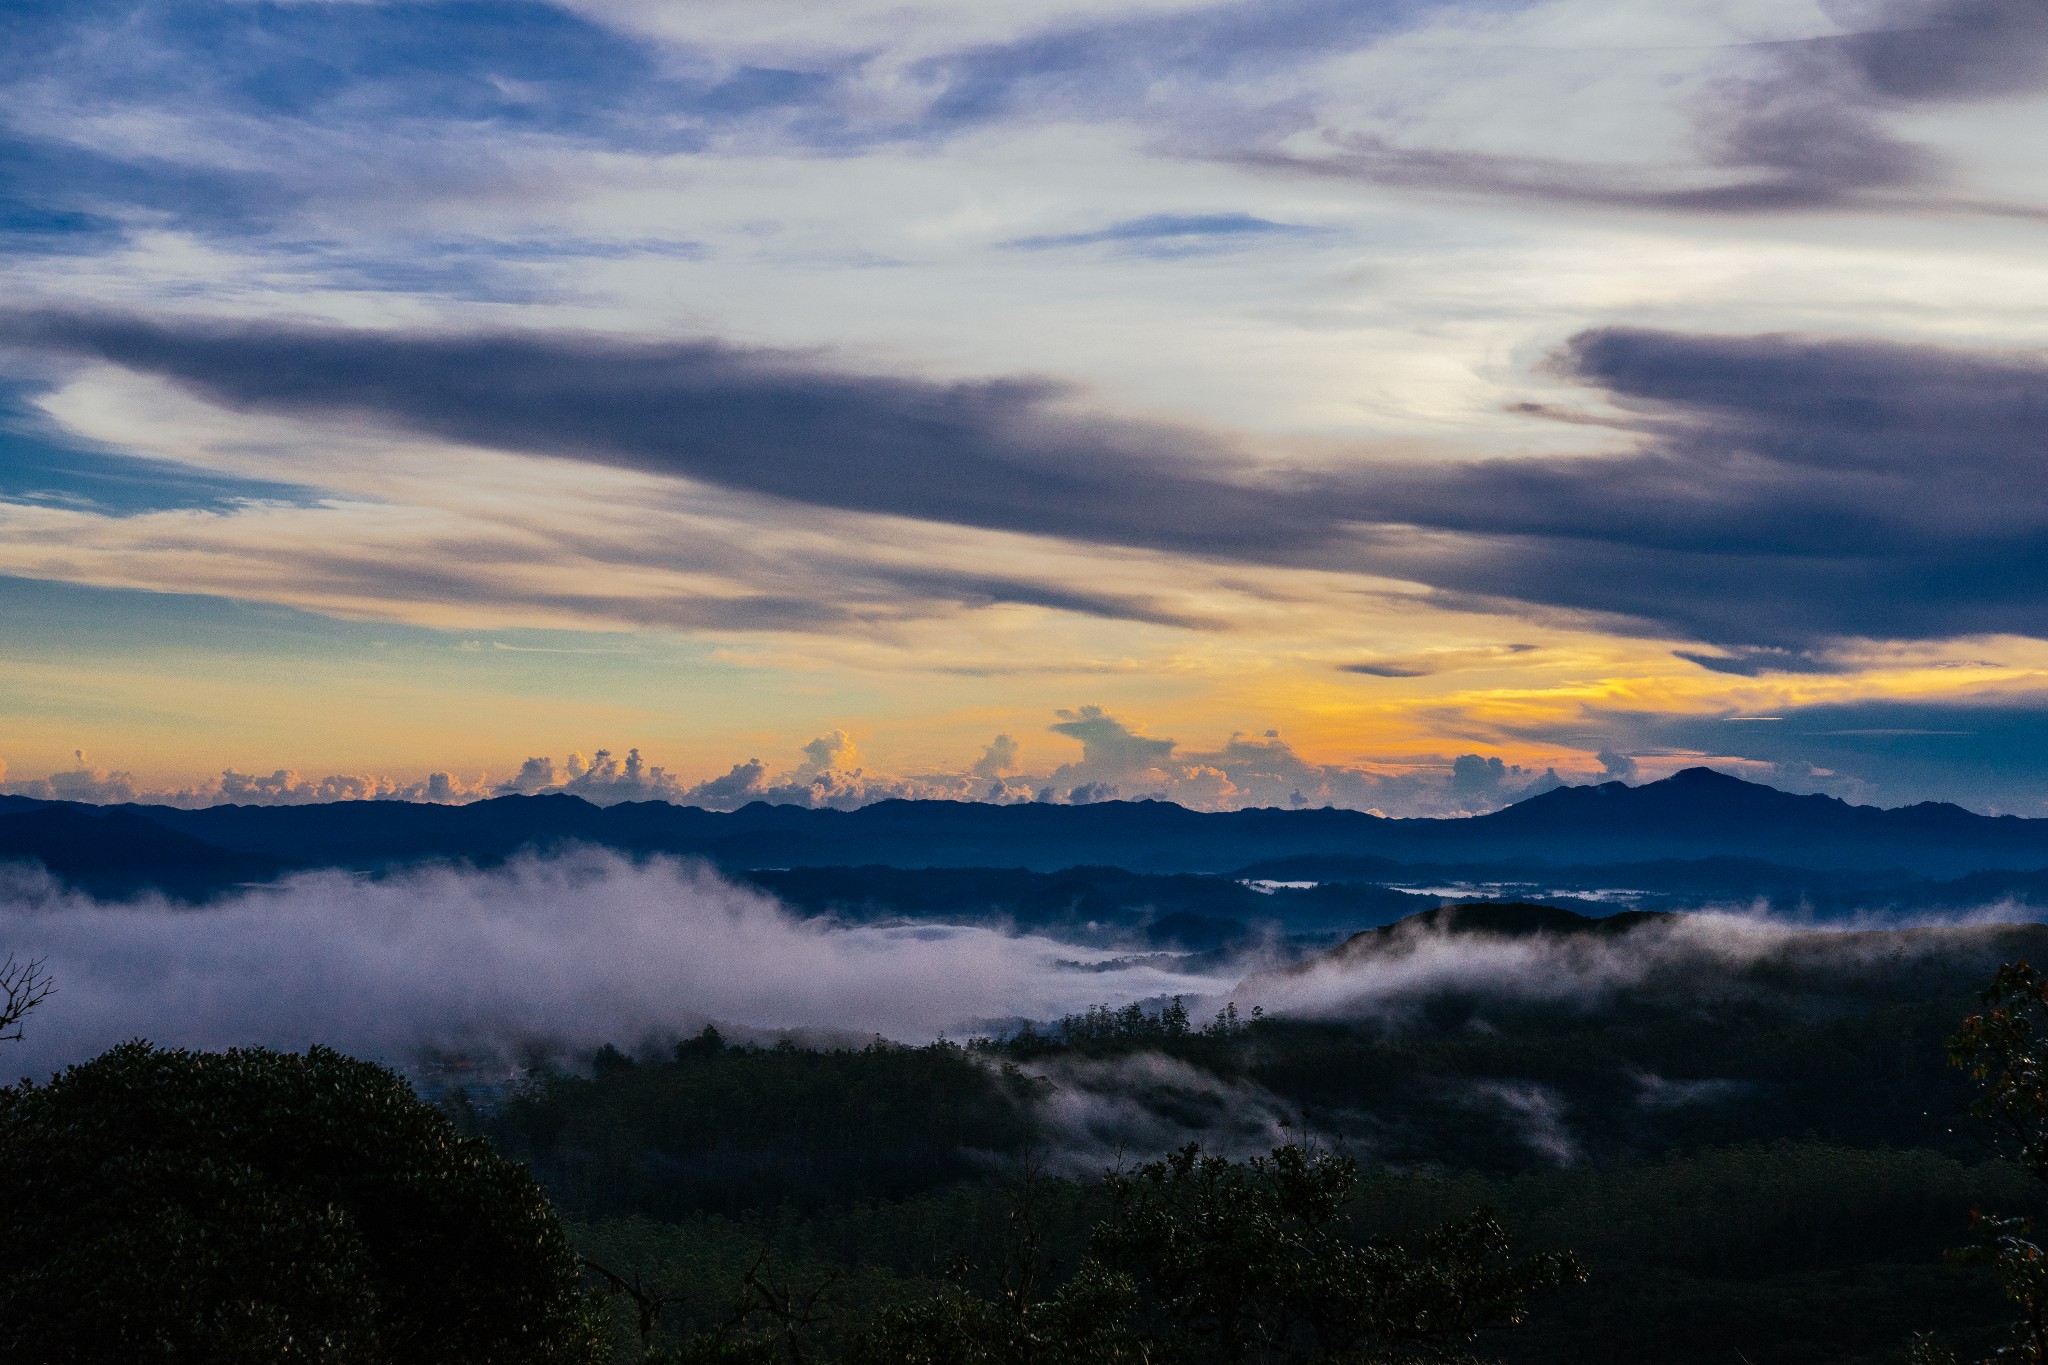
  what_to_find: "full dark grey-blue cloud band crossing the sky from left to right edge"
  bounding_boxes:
[24,313,2048,654]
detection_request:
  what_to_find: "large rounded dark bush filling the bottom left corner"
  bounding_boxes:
[0,1042,596,1365]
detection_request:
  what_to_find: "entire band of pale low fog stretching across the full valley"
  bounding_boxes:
[0,849,2032,1089]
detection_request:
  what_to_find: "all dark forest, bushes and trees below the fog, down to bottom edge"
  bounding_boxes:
[19,916,2048,1365]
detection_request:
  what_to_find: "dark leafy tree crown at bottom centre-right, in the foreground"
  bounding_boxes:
[852,1146,1581,1365]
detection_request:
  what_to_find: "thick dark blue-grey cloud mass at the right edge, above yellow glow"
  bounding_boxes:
[1374,329,2048,654]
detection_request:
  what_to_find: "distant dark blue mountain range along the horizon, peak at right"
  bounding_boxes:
[12,767,2048,898]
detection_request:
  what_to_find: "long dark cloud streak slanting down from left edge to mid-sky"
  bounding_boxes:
[0,313,1331,559]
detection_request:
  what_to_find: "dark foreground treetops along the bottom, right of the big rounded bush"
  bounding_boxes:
[561,1146,1577,1365]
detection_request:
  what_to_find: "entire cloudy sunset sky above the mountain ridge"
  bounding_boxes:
[0,0,2048,817]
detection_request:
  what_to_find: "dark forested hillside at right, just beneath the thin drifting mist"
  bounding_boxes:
[1001,929,2048,1173]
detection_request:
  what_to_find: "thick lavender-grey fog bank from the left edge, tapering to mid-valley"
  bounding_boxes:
[0,851,1229,1070]
